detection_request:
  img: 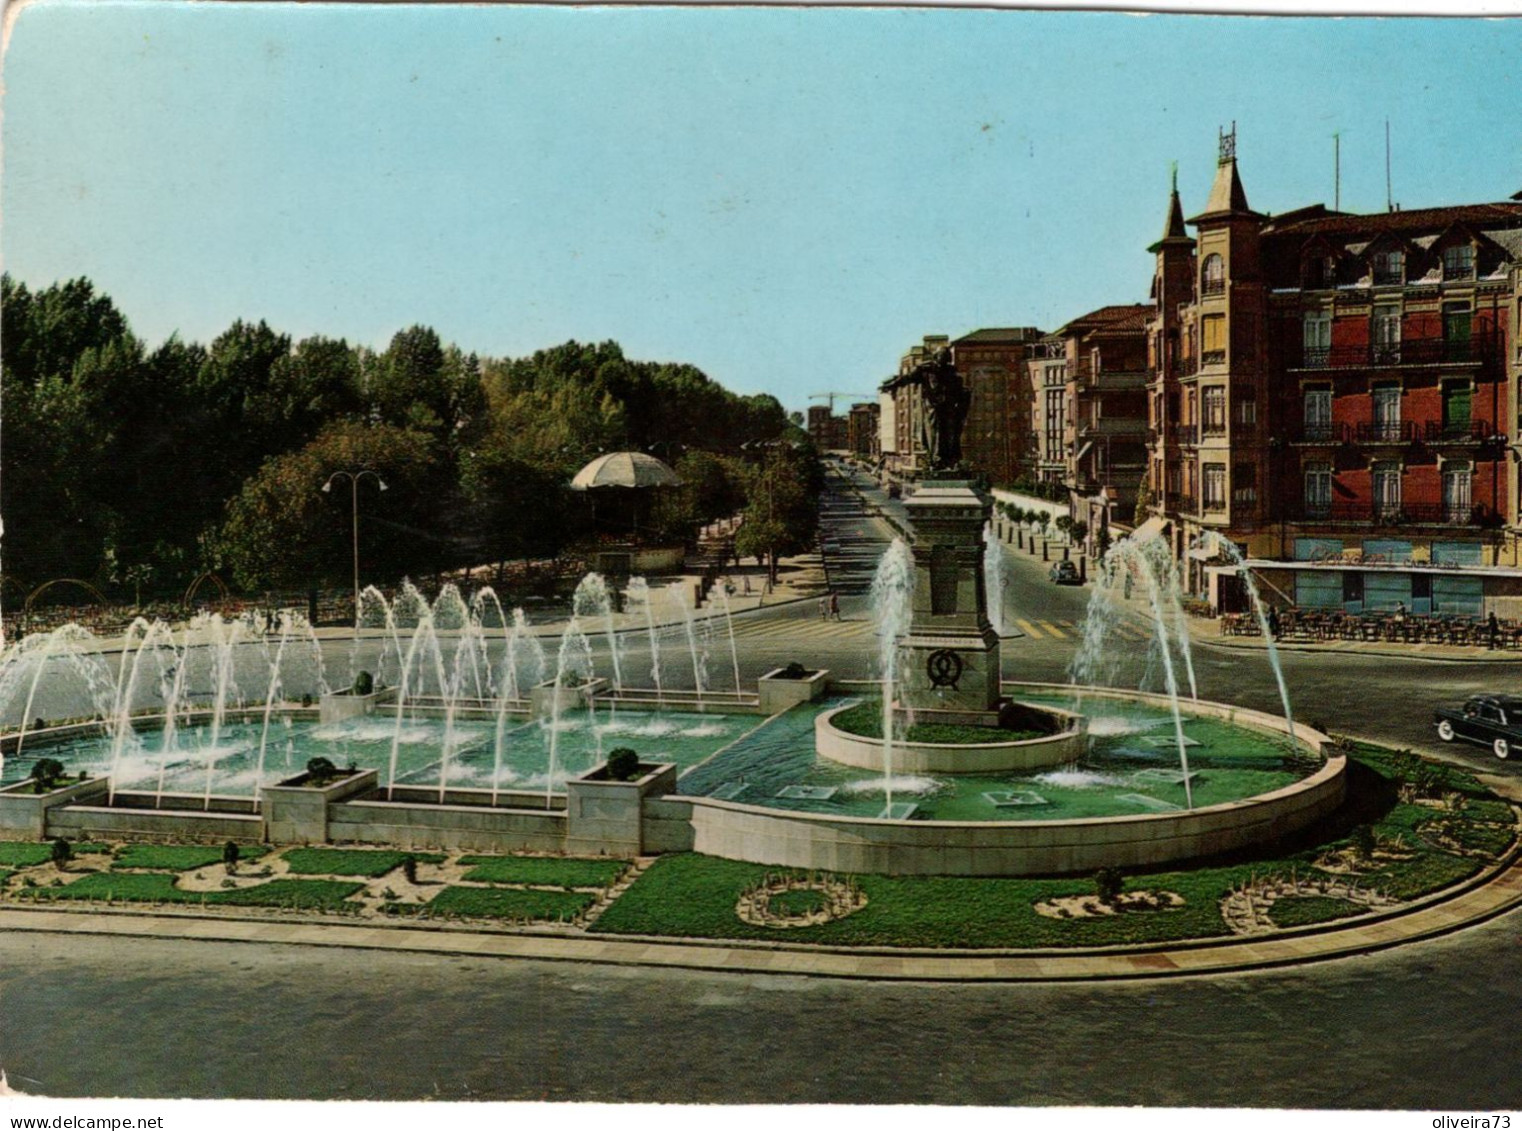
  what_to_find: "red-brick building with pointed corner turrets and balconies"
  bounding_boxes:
[1148,132,1522,615]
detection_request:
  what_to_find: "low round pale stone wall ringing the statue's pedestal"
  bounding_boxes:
[814,703,1084,773]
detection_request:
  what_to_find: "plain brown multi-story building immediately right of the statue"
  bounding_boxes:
[951,326,1041,486]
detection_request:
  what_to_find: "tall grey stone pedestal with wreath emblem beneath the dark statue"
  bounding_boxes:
[900,478,1000,725]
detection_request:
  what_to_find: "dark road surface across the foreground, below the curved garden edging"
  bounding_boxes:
[0,913,1522,1108]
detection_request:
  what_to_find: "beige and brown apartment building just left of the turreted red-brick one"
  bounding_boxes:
[1027,303,1152,530]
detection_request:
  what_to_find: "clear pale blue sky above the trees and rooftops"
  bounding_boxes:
[0,0,1522,408]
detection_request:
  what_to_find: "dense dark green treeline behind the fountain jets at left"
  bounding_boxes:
[0,276,811,600]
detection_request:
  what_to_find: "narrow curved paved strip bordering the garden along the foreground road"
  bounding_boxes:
[0,854,1522,982]
